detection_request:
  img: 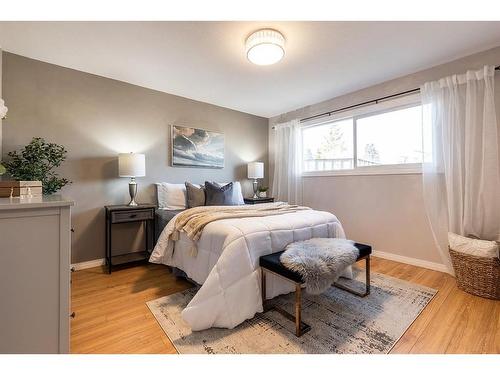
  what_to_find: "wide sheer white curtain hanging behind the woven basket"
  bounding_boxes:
[420,66,500,273]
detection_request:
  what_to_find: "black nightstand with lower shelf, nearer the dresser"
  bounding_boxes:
[104,204,156,273]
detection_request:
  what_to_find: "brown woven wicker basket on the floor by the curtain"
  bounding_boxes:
[449,249,500,300]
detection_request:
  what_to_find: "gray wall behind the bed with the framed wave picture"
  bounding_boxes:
[1,51,268,263]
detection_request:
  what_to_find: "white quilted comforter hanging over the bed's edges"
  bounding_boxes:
[150,210,345,331]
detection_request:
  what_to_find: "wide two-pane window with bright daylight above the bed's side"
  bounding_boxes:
[302,104,423,174]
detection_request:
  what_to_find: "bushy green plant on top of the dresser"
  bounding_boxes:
[3,137,71,195]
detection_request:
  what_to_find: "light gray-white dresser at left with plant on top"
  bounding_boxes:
[0,195,73,353]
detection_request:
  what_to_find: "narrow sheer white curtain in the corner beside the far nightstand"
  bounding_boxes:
[272,120,302,204]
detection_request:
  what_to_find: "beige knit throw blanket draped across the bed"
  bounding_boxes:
[164,202,310,256]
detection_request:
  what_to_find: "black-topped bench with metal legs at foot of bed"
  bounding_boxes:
[259,243,372,336]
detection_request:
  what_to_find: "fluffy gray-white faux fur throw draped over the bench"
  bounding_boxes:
[280,238,359,294]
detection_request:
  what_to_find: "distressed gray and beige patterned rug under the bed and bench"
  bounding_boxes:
[147,271,437,354]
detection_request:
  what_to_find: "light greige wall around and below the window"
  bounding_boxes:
[269,47,500,269]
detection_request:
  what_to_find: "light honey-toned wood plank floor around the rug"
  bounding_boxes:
[71,257,500,353]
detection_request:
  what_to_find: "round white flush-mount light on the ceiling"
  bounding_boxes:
[245,29,285,65]
